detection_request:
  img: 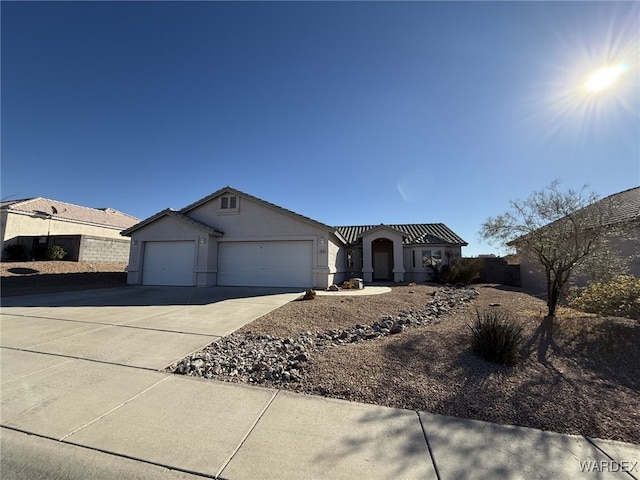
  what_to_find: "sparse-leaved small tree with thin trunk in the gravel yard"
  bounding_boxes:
[480,181,620,321]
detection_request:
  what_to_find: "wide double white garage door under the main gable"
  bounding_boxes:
[218,241,313,288]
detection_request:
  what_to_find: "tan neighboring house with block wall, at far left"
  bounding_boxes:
[0,197,140,263]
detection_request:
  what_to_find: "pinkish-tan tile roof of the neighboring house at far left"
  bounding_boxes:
[0,197,140,229]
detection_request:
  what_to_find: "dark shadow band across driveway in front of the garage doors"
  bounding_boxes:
[2,286,303,307]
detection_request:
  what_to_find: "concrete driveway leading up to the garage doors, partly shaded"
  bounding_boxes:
[0,287,301,371]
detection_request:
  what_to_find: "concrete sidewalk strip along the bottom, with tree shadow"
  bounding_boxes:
[1,362,640,480]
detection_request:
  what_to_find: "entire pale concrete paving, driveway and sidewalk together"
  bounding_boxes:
[0,286,640,480]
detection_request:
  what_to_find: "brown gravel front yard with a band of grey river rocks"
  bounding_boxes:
[169,285,640,444]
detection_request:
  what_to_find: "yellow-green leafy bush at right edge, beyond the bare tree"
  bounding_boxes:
[568,275,640,319]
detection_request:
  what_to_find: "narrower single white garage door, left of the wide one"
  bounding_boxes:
[142,242,195,286]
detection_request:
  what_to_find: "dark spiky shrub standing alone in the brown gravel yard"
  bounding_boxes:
[469,309,522,365]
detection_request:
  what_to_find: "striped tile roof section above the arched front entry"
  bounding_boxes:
[335,223,467,246]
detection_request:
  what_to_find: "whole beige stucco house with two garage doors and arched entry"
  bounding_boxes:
[122,187,467,288]
